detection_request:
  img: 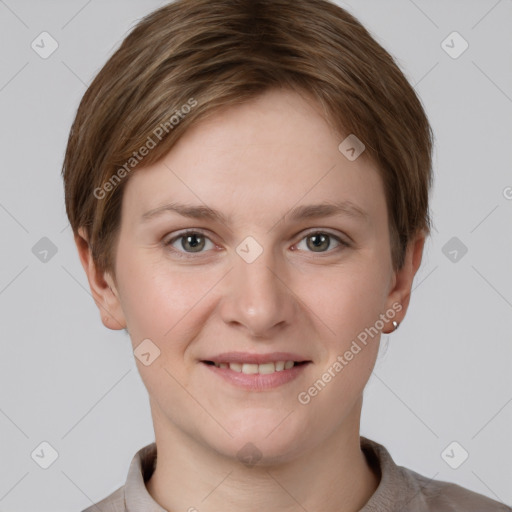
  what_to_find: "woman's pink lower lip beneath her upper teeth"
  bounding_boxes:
[201,362,310,391]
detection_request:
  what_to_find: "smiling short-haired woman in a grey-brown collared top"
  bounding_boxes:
[63,0,510,512]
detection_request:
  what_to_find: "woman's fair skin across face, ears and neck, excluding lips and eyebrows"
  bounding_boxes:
[76,89,425,512]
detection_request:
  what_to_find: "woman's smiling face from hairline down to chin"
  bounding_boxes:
[80,90,422,460]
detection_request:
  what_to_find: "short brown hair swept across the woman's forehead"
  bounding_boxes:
[62,0,433,280]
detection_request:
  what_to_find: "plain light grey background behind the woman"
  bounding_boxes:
[0,0,512,512]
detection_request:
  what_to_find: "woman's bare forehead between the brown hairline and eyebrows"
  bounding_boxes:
[119,90,385,228]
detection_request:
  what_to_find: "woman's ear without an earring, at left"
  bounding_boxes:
[75,227,126,330]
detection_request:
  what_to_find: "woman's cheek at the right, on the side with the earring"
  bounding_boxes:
[300,260,386,416]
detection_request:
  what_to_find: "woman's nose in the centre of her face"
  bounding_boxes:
[220,242,298,338]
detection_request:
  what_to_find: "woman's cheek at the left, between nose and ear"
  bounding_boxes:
[116,258,211,405]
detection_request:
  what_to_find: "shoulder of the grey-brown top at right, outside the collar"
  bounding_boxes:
[401,466,512,512]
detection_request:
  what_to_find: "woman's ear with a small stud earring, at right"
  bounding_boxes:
[385,230,426,333]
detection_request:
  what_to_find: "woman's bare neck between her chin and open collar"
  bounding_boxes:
[146,404,379,512]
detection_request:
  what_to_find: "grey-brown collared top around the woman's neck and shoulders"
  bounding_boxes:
[82,436,512,512]
